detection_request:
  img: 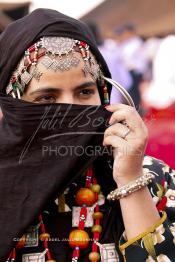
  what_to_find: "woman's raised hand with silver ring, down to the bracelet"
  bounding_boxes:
[103,104,148,186]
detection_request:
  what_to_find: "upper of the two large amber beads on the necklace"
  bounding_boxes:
[75,188,96,206]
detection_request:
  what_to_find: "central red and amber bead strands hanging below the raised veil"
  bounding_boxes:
[69,168,103,262]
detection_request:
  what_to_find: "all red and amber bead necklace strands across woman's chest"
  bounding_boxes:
[6,168,103,262]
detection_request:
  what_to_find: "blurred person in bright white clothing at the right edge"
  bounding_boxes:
[144,35,175,109]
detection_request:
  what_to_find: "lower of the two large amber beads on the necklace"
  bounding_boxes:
[69,229,89,249]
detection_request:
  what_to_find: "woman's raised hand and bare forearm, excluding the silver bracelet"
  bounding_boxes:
[104,104,160,240]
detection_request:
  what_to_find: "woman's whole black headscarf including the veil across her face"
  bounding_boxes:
[0,9,113,261]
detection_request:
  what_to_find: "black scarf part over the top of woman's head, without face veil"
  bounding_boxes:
[0,9,110,92]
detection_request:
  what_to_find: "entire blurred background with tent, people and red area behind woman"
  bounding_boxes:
[0,0,175,168]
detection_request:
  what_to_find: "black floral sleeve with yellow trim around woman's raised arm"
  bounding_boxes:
[120,156,175,262]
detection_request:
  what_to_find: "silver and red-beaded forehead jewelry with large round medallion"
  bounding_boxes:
[6,37,101,98]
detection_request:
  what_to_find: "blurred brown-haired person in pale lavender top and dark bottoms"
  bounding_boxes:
[114,23,147,108]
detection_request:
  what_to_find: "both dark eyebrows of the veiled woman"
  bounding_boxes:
[29,81,97,95]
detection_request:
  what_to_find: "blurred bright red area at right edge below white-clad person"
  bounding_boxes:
[144,105,175,169]
